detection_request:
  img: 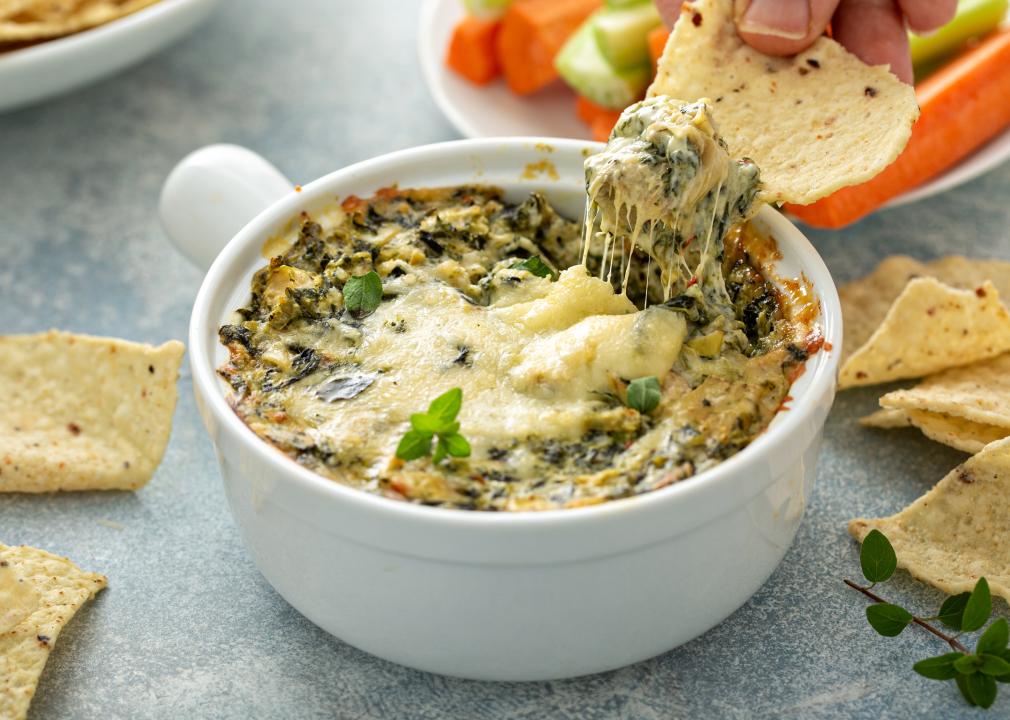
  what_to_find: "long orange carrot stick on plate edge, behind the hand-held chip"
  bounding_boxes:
[787,30,1010,227]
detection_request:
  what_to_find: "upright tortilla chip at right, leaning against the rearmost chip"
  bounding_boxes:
[838,278,1010,389]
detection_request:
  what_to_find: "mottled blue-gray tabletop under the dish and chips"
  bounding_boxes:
[0,0,1010,720]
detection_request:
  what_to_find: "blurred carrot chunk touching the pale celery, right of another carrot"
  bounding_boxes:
[497,0,600,95]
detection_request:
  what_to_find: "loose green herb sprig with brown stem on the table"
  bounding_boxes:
[844,530,1010,708]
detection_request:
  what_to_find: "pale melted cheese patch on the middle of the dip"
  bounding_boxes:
[268,266,687,462]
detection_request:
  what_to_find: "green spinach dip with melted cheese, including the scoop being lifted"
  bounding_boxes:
[219,97,820,511]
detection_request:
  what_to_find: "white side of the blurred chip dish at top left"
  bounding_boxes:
[0,0,220,112]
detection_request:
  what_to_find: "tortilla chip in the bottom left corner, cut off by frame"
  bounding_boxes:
[0,544,106,720]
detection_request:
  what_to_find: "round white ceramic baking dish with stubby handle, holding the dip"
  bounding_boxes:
[161,138,841,681]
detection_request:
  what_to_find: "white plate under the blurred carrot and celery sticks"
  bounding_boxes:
[418,0,1010,207]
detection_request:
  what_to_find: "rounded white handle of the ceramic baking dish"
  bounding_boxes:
[159,144,294,271]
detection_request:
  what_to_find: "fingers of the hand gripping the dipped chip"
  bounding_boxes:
[655,0,957,83]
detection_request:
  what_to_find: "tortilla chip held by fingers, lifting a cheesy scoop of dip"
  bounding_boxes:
[648,0,919,205]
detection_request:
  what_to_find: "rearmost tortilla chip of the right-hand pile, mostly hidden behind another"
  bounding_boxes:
[838,255,1010,365]
